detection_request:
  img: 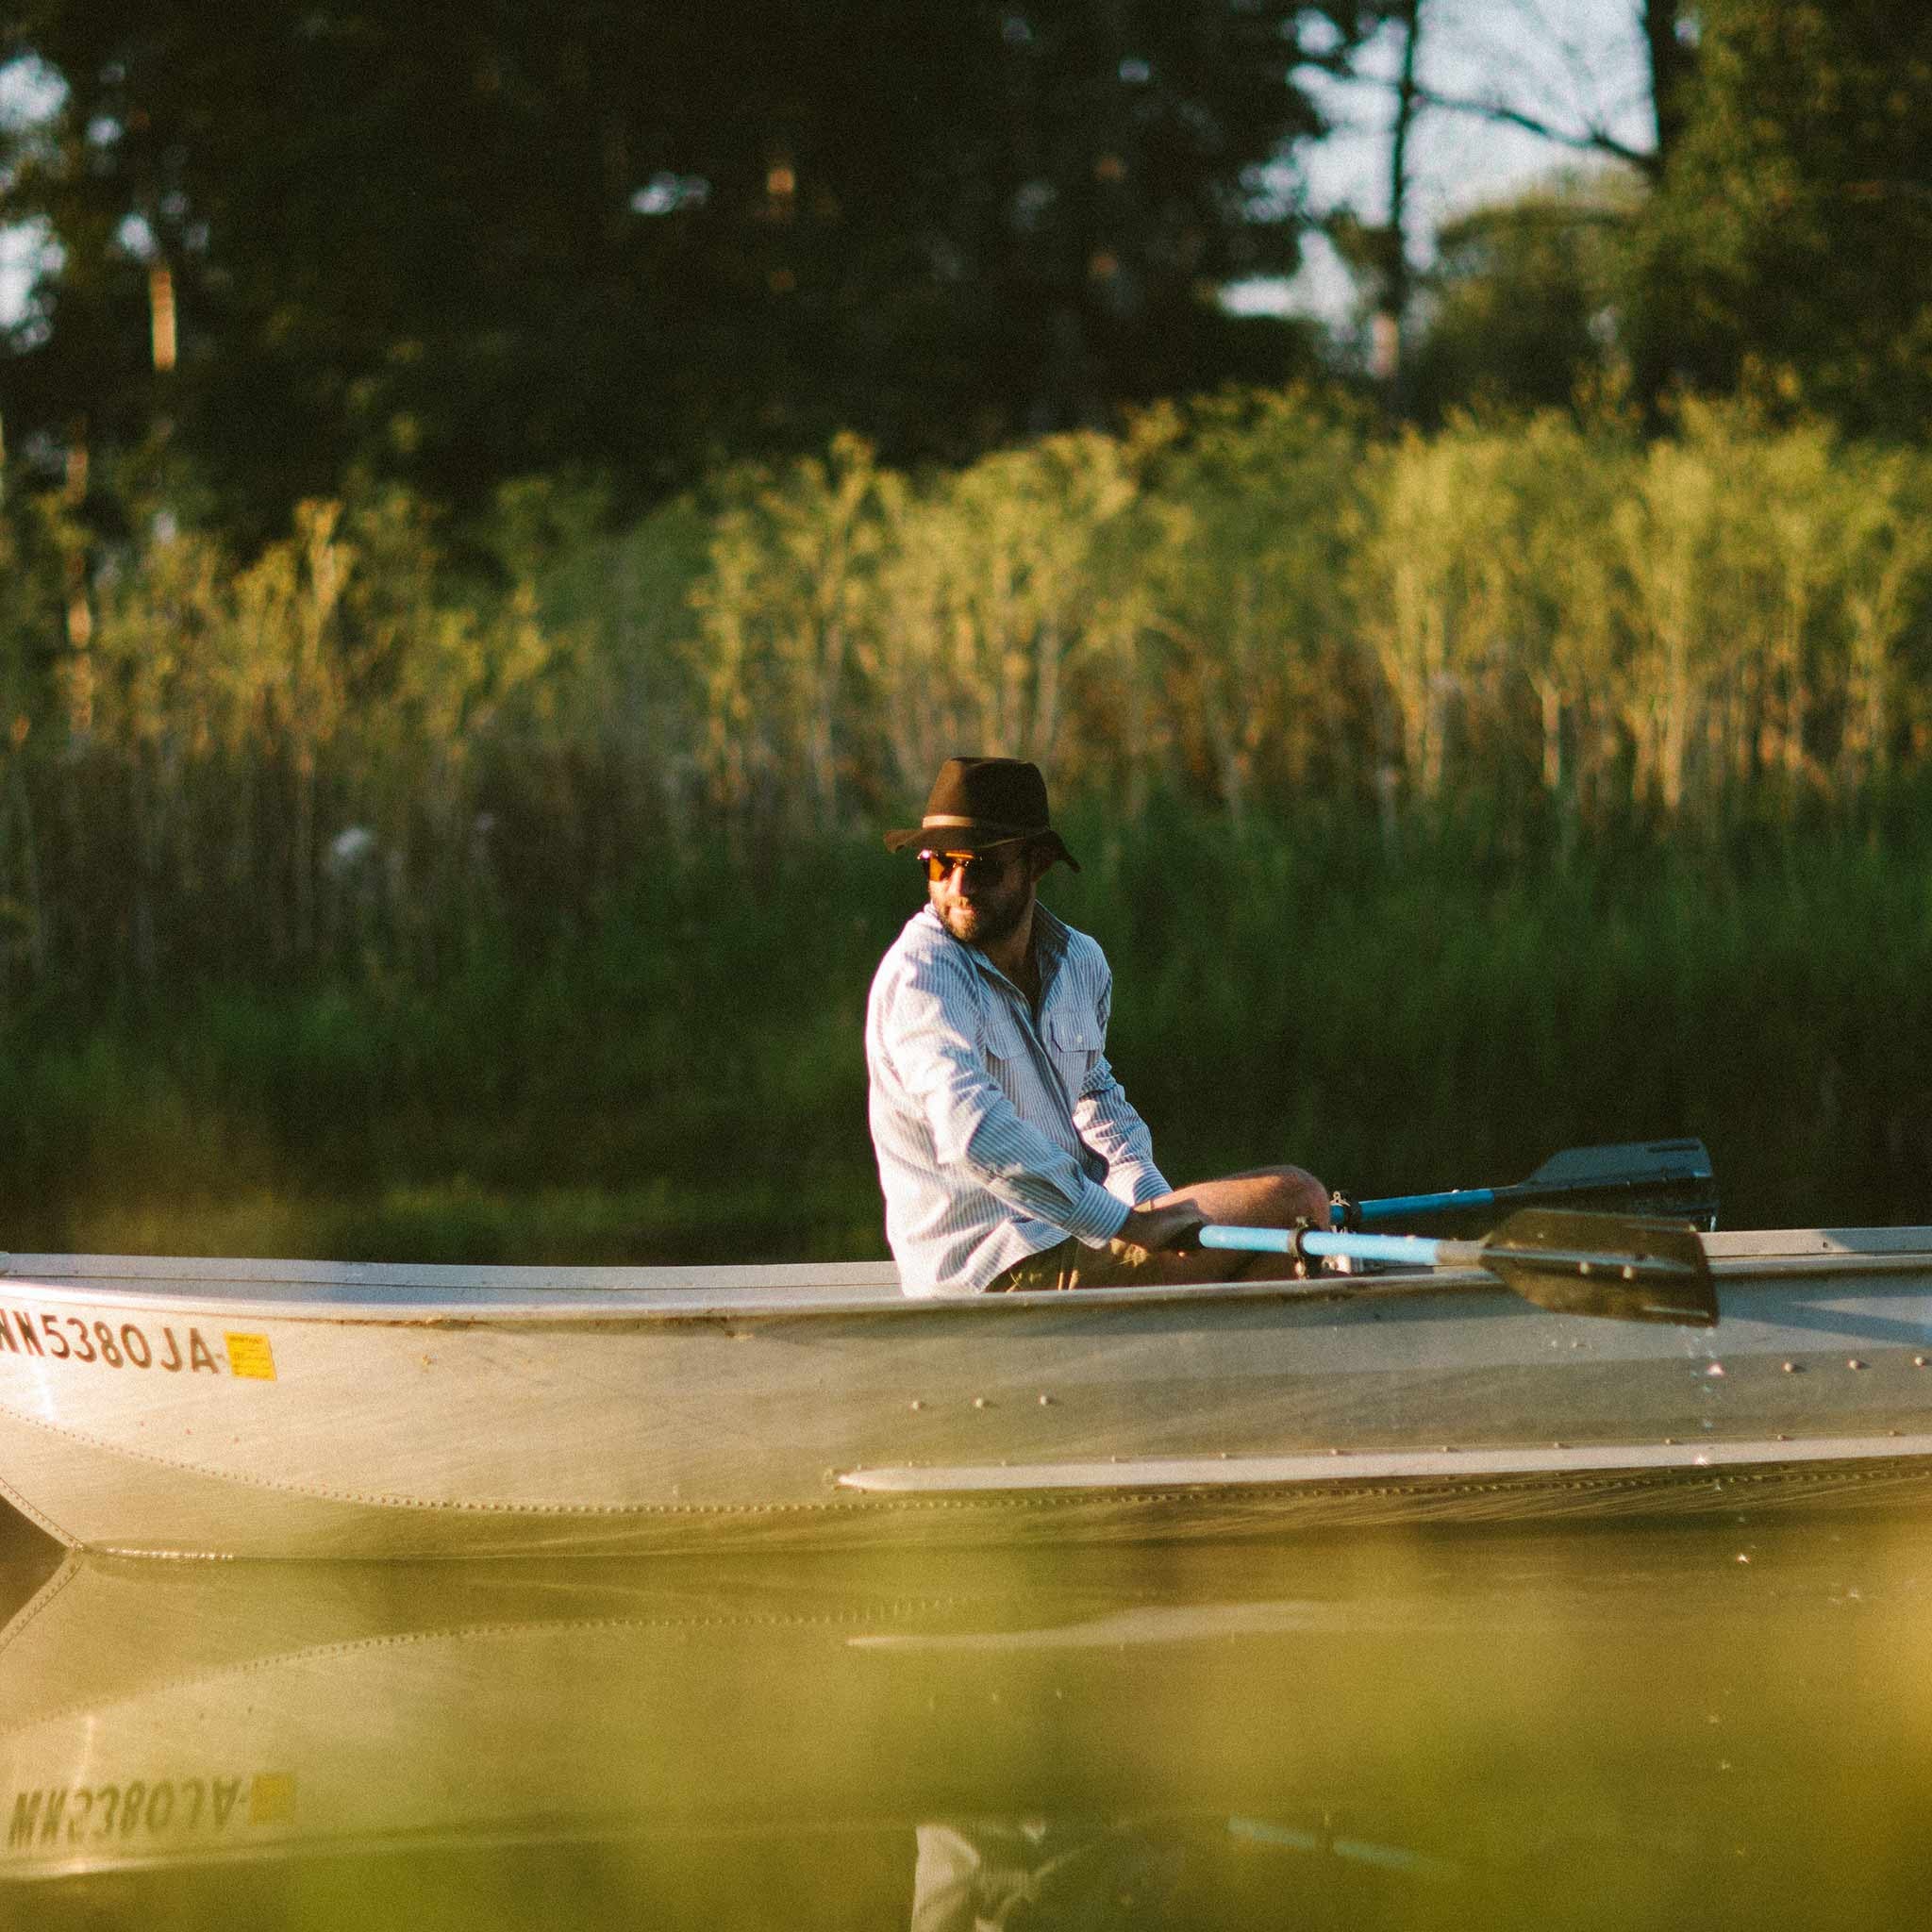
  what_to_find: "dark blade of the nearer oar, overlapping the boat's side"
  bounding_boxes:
[1482,1208,1718,1327]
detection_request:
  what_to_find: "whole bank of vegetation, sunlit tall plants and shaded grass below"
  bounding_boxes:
[0,404,1932,1259]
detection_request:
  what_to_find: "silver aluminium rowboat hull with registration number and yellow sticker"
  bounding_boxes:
[0,1231,1932,1557]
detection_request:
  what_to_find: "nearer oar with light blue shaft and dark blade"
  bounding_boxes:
[1196,1208,1718,1327]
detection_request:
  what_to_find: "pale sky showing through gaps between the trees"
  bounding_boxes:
[0,0,1654,328]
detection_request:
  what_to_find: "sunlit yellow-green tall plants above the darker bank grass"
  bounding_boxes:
[0,392,1932,1005]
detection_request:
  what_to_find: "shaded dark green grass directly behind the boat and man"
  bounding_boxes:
[0,800,1932,1259]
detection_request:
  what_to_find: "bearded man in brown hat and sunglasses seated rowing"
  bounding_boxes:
[866,758,1327,1294]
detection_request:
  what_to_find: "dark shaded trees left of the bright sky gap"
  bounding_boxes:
[0,0,1358,524]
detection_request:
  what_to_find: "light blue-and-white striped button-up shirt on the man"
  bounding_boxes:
[866,907,1169,1294]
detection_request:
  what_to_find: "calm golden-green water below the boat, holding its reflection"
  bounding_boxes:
[0,1517,1932,1932]
